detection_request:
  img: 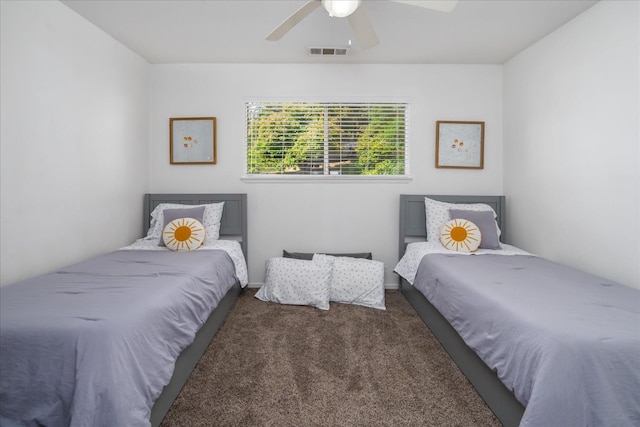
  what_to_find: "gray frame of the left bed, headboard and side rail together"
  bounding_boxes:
[142,194,248,427]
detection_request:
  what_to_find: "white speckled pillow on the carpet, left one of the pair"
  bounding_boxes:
[255,258,331,310]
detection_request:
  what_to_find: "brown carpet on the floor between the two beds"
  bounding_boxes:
[162,290,500,427]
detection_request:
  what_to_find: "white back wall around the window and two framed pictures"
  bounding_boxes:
[149,64,503,286]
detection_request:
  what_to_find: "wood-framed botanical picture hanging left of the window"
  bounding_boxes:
[169,117,217,165]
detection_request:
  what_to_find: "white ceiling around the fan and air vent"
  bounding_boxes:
[63,0,597,64]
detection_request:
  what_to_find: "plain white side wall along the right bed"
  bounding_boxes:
[504,1,640,287]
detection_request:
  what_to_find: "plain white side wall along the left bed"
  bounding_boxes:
[0,1,149,285]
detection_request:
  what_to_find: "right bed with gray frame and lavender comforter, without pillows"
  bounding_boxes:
[395,195,640,426]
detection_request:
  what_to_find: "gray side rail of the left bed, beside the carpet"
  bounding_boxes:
[150,282,242,427]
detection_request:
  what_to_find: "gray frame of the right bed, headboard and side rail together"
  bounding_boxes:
[399,194,524,427]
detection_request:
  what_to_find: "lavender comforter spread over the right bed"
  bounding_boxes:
[414,254,640,427]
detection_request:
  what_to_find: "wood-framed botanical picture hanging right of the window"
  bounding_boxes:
[436,120,484,169]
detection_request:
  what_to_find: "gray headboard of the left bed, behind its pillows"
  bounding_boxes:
[142,194,248,258]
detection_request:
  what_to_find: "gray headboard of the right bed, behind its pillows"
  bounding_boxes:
[399,194,508,258]
